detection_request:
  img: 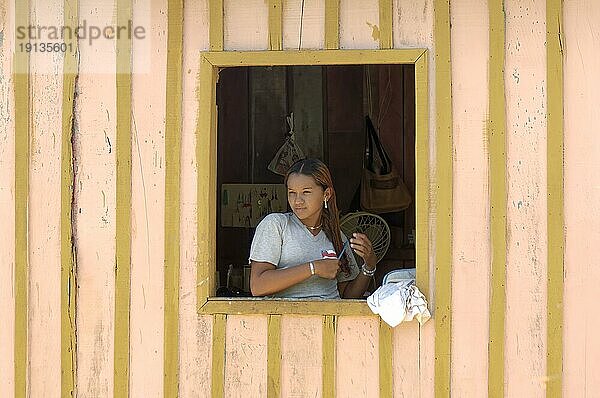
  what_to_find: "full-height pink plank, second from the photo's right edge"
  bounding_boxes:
[504,0,548,397]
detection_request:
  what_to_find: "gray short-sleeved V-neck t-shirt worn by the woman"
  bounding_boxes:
[249,213,359,299]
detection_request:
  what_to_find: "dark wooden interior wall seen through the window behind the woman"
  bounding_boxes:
[216,65,415,290]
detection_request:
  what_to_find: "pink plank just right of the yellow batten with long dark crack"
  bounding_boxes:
[72,0,117,397]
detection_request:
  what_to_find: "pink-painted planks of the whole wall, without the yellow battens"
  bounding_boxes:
[0,0,600,398]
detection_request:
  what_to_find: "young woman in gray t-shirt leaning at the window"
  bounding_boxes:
[250,159,377,299]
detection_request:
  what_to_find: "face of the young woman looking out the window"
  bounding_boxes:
[287,173,329,226]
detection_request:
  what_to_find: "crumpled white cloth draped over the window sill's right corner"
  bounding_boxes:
[367,279,431,327]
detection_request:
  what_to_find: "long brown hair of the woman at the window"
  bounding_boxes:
[285,159,350,273]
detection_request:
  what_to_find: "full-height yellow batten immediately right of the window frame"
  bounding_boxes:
[434,0,453,397]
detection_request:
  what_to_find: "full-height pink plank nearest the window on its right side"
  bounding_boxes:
[450,1,496,398]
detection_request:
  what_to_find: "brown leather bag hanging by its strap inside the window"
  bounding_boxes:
[360,116,412,214]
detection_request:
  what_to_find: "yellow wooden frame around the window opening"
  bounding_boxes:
[196,48,429,315]
